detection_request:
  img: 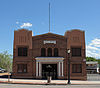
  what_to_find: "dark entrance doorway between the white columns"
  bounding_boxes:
[42,64,57,79]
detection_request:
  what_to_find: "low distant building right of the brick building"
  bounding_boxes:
[86,61,99,74]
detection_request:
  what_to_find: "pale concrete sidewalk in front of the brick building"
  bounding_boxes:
[0,78,100,85]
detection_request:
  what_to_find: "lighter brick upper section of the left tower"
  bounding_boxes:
[14,29,32,49]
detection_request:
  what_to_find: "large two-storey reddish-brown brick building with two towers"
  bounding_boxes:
[12,29,87,80]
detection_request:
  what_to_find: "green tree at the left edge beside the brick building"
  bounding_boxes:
[0,51,12,72]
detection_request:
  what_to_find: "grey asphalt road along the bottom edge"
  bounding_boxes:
[0,83,100,88]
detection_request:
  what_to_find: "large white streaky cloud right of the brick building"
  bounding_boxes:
[86,38,100,58]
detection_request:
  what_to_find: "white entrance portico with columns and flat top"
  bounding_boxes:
[35,57,64,77]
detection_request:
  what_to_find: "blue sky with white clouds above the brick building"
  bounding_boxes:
[0,0,100,58]
